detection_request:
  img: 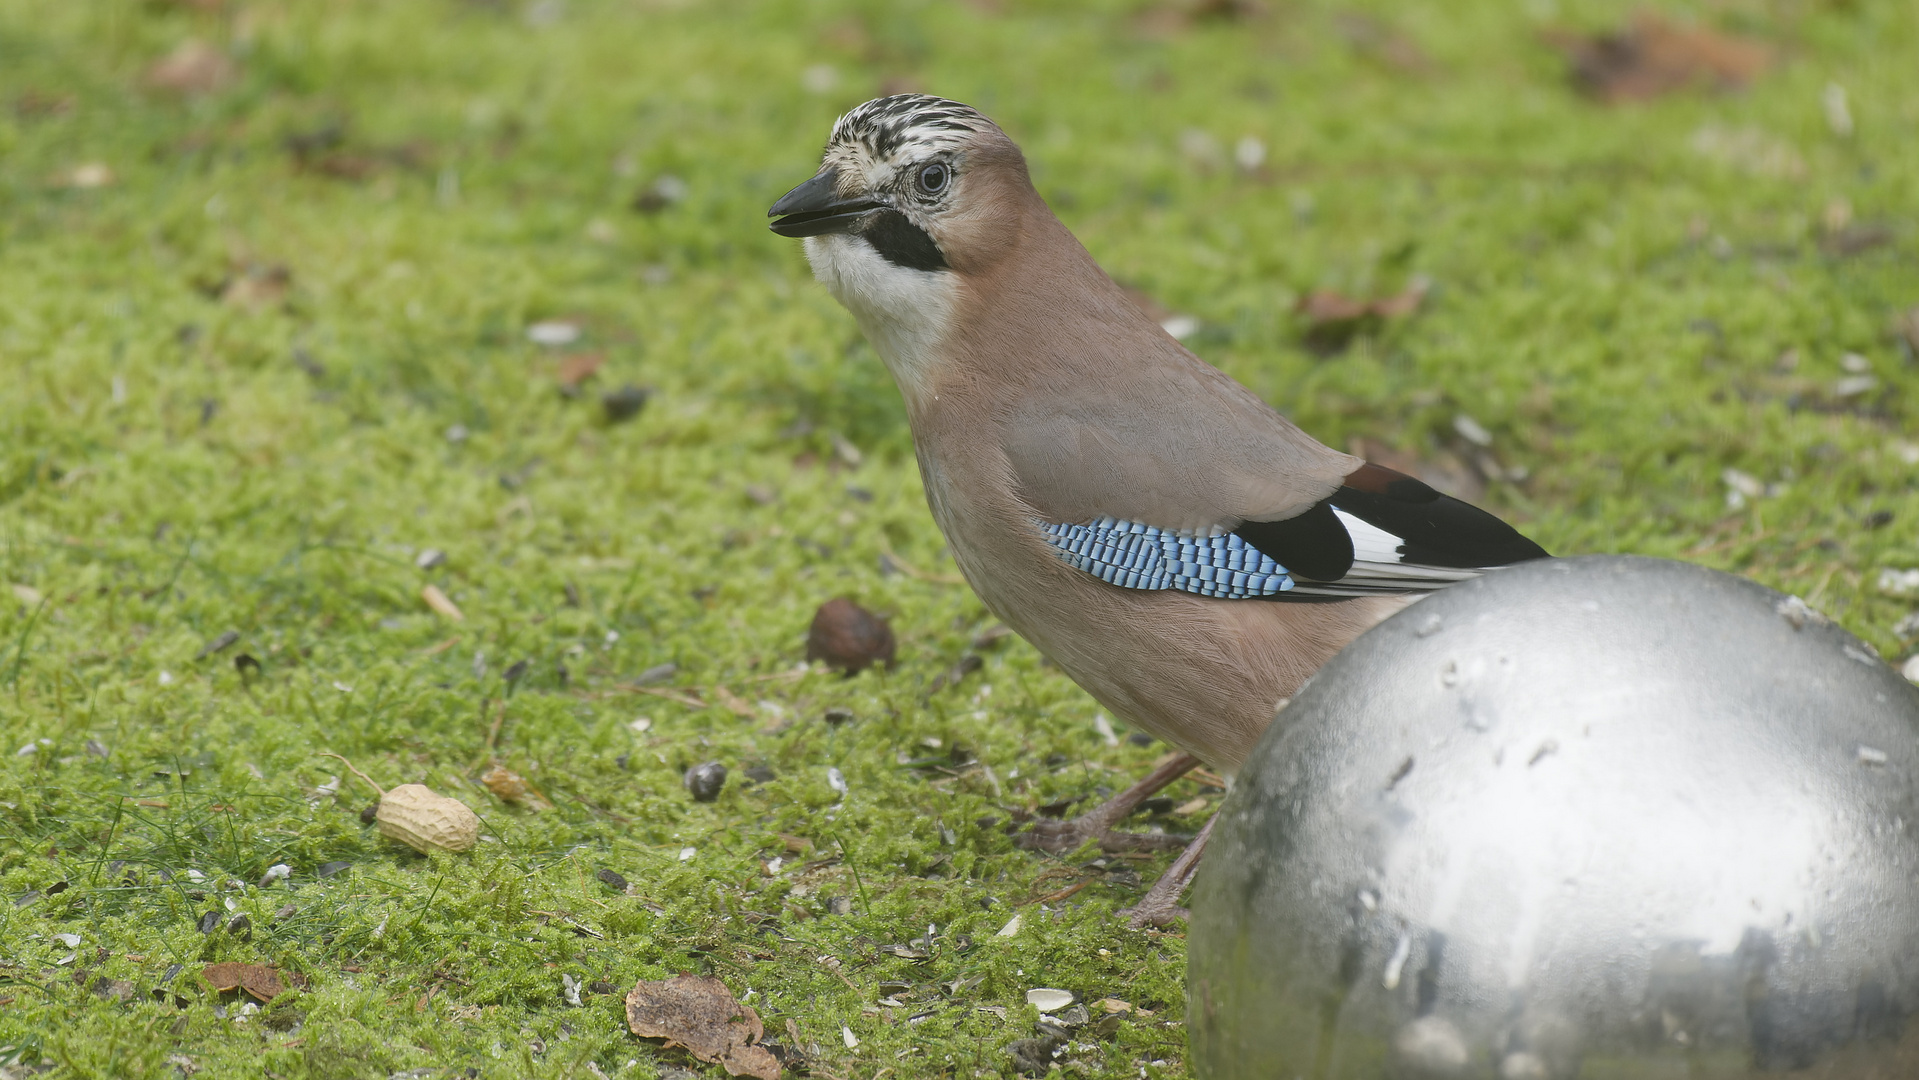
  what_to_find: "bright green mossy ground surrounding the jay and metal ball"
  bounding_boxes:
[0,0,1919,1080]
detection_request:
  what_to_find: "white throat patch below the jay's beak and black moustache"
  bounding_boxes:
[806,234,958,405]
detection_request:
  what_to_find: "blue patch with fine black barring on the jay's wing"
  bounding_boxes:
[1040,518,1293,600]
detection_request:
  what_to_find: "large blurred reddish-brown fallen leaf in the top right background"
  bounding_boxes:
[1545,12,1773,106]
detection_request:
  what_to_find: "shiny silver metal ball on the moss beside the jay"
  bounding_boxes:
[1188,556,1919,1080]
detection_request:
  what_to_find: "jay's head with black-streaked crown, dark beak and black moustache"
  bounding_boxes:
[768,94,1032,283]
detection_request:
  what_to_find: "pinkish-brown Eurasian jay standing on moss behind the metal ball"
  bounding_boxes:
[768,94,1547,925]
